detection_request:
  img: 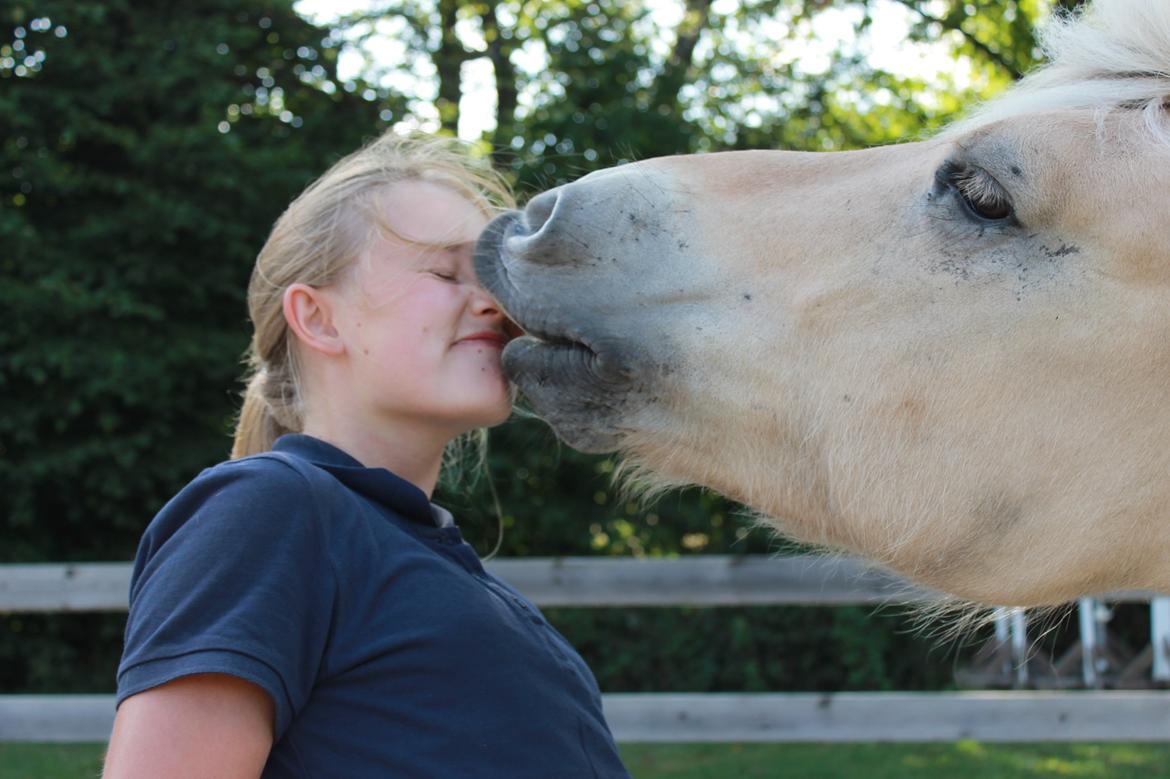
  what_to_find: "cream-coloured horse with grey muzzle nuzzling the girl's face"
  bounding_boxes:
[477,0,1170,605]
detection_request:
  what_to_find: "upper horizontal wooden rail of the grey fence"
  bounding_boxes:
[0,554,1150,613]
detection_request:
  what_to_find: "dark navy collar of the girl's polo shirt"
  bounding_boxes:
[273,433,435,528]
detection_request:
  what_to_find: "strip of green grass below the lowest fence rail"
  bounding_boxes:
[9,742,1170,779]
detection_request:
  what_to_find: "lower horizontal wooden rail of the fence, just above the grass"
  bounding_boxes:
[0,691,1170,743]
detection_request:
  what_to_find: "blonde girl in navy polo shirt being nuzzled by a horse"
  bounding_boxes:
[104,136,628,779]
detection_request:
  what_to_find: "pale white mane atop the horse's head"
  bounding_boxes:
[944,0,1170,145]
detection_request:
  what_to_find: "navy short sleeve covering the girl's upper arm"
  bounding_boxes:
[117,456,336,738]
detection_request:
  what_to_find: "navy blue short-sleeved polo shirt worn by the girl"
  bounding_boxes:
[118,435,629,779]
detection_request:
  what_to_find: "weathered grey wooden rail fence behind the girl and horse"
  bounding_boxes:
[0,556,1170,742]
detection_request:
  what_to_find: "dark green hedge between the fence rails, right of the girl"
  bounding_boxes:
[548,607,970,692]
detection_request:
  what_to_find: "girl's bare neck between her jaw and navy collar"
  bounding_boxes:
[303,416,450,497]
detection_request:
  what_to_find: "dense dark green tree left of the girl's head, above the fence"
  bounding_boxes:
[0,0,393,560]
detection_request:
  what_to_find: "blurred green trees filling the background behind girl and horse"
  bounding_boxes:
[0,0,1109,691]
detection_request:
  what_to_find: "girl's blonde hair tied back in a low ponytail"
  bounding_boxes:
[232,133,514,457]
